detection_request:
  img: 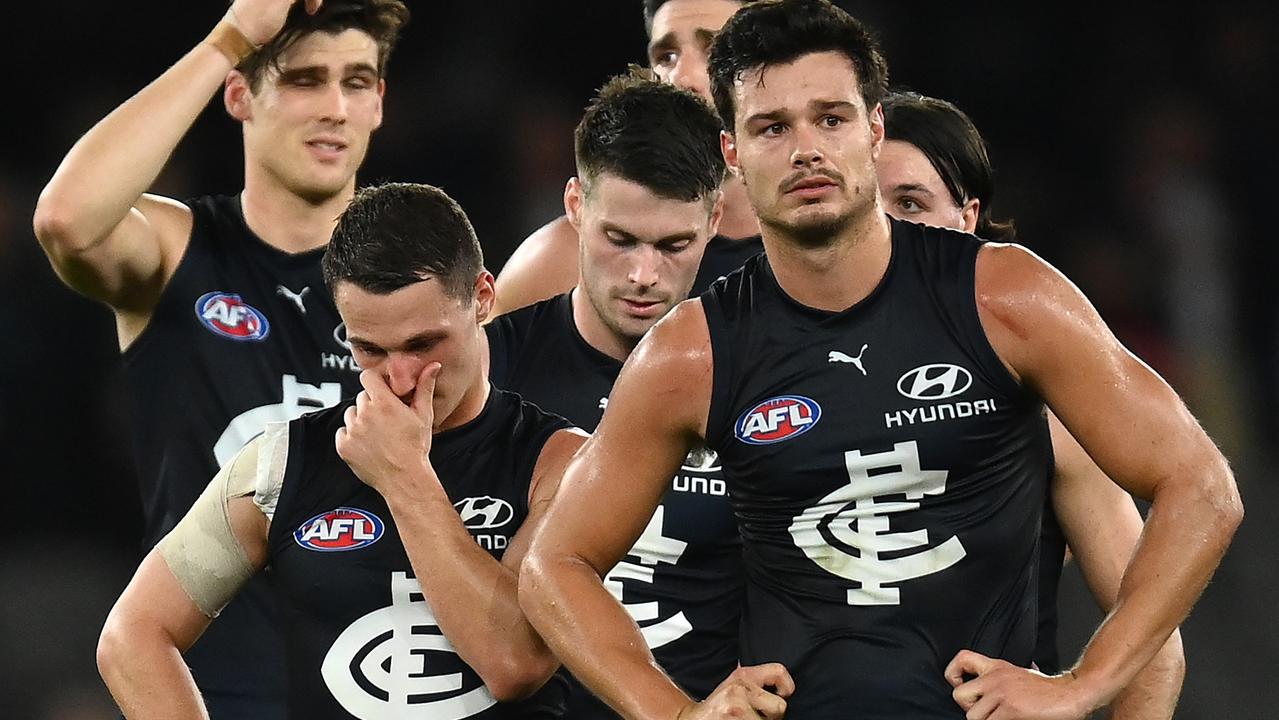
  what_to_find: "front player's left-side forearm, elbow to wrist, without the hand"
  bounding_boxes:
[519,558,692,720]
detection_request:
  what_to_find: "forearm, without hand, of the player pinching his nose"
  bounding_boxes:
[388,477,559,700]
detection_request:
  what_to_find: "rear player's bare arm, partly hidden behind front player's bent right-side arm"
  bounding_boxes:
[1049,413,1186,720]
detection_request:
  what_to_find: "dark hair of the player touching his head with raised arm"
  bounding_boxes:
[237,0,409,92]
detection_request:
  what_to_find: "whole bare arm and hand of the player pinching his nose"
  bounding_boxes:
[336,363,565,702]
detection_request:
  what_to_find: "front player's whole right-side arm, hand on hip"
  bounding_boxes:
[946,244,1243,719]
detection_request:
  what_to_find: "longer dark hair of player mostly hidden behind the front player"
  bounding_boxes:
[884,92,1017,243]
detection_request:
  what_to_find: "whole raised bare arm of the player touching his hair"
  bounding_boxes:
[33,0,320,335]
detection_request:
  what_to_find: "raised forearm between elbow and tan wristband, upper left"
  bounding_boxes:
[36,37,231,252]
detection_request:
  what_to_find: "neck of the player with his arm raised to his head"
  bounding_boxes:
[240,171,356,253]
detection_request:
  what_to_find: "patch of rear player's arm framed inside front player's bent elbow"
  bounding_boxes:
[1049,416,1142,611]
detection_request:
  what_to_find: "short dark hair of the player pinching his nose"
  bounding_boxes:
[321,183,483,301]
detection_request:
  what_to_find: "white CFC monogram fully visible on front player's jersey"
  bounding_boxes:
[790,440,967,605]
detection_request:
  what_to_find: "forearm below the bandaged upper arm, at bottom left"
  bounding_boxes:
[97,625,208,720]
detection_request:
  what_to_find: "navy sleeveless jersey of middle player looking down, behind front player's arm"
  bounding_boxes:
[487,294,743,719]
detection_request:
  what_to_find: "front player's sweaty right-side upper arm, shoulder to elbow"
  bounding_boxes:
[977,246,1219,499]
